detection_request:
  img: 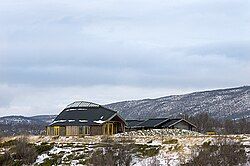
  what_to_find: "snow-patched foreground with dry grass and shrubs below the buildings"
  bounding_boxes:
[0,129,250,166]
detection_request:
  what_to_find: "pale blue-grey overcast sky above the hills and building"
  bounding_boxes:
[0,0,250,116]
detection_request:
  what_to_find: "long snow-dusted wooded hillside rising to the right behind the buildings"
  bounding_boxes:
[106,86,250,119]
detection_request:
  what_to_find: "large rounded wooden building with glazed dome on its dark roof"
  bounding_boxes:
[46,101,126,136]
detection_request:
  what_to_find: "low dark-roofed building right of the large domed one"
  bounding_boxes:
[127,118,196,131]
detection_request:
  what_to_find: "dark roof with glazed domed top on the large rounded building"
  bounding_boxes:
[51,101,122,126]
